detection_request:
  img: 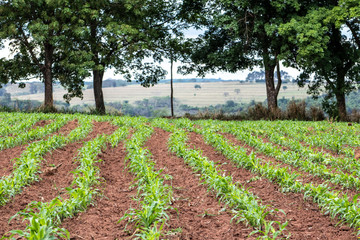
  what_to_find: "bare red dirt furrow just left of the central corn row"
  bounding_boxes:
[61,144,137,240]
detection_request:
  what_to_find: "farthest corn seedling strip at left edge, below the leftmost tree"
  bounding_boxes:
[0,113,54,137]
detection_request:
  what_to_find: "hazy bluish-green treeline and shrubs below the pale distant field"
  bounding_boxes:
[4,91,360,121]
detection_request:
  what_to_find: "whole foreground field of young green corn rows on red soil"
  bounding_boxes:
[0,113,360,239]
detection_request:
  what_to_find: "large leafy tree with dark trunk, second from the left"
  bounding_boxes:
[74,0,183,114]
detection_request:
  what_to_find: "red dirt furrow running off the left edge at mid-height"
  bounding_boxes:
[0,120,78,177]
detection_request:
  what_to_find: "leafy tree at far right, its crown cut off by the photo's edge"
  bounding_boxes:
[280,1,360,121]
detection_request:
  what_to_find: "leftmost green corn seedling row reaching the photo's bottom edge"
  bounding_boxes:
[5,118,129,240]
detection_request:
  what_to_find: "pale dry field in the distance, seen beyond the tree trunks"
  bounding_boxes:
[12,82,308,107]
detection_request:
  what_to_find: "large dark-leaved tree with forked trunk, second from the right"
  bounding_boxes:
[183,0,300,111]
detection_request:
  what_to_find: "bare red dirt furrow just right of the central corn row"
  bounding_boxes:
[145,128,253,239]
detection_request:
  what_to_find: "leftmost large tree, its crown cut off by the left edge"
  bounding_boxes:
[0,0,87,109]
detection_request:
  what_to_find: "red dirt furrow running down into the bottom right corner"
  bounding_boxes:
[189,133,356,240]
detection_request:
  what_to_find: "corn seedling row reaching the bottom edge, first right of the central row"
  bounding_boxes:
[153,119,288,239]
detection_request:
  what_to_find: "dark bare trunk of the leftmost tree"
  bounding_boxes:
[42,43,54,110]
